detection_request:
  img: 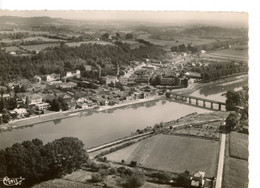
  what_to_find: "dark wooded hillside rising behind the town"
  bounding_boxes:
[0,44,165,81]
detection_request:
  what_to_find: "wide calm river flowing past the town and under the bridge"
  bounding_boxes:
[0,83,246,149]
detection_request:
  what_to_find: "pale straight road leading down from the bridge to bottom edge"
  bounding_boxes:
[216,134,226,188]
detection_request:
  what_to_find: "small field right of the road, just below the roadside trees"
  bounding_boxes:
[229,132,248,160]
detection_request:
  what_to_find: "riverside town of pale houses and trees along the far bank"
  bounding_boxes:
[0,34,247,127]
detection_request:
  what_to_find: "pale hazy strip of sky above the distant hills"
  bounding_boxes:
[0,10,248,26]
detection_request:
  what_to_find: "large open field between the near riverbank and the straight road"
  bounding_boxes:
[106,135,219,177]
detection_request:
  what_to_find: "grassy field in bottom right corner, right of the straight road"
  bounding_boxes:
[222,157,248,188]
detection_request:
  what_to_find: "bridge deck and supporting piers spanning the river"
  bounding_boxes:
[168,93,226,111]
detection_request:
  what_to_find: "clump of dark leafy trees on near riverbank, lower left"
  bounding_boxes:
[0,137,88,187]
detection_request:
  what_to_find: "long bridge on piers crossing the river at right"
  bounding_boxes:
[166,93,226,111]
